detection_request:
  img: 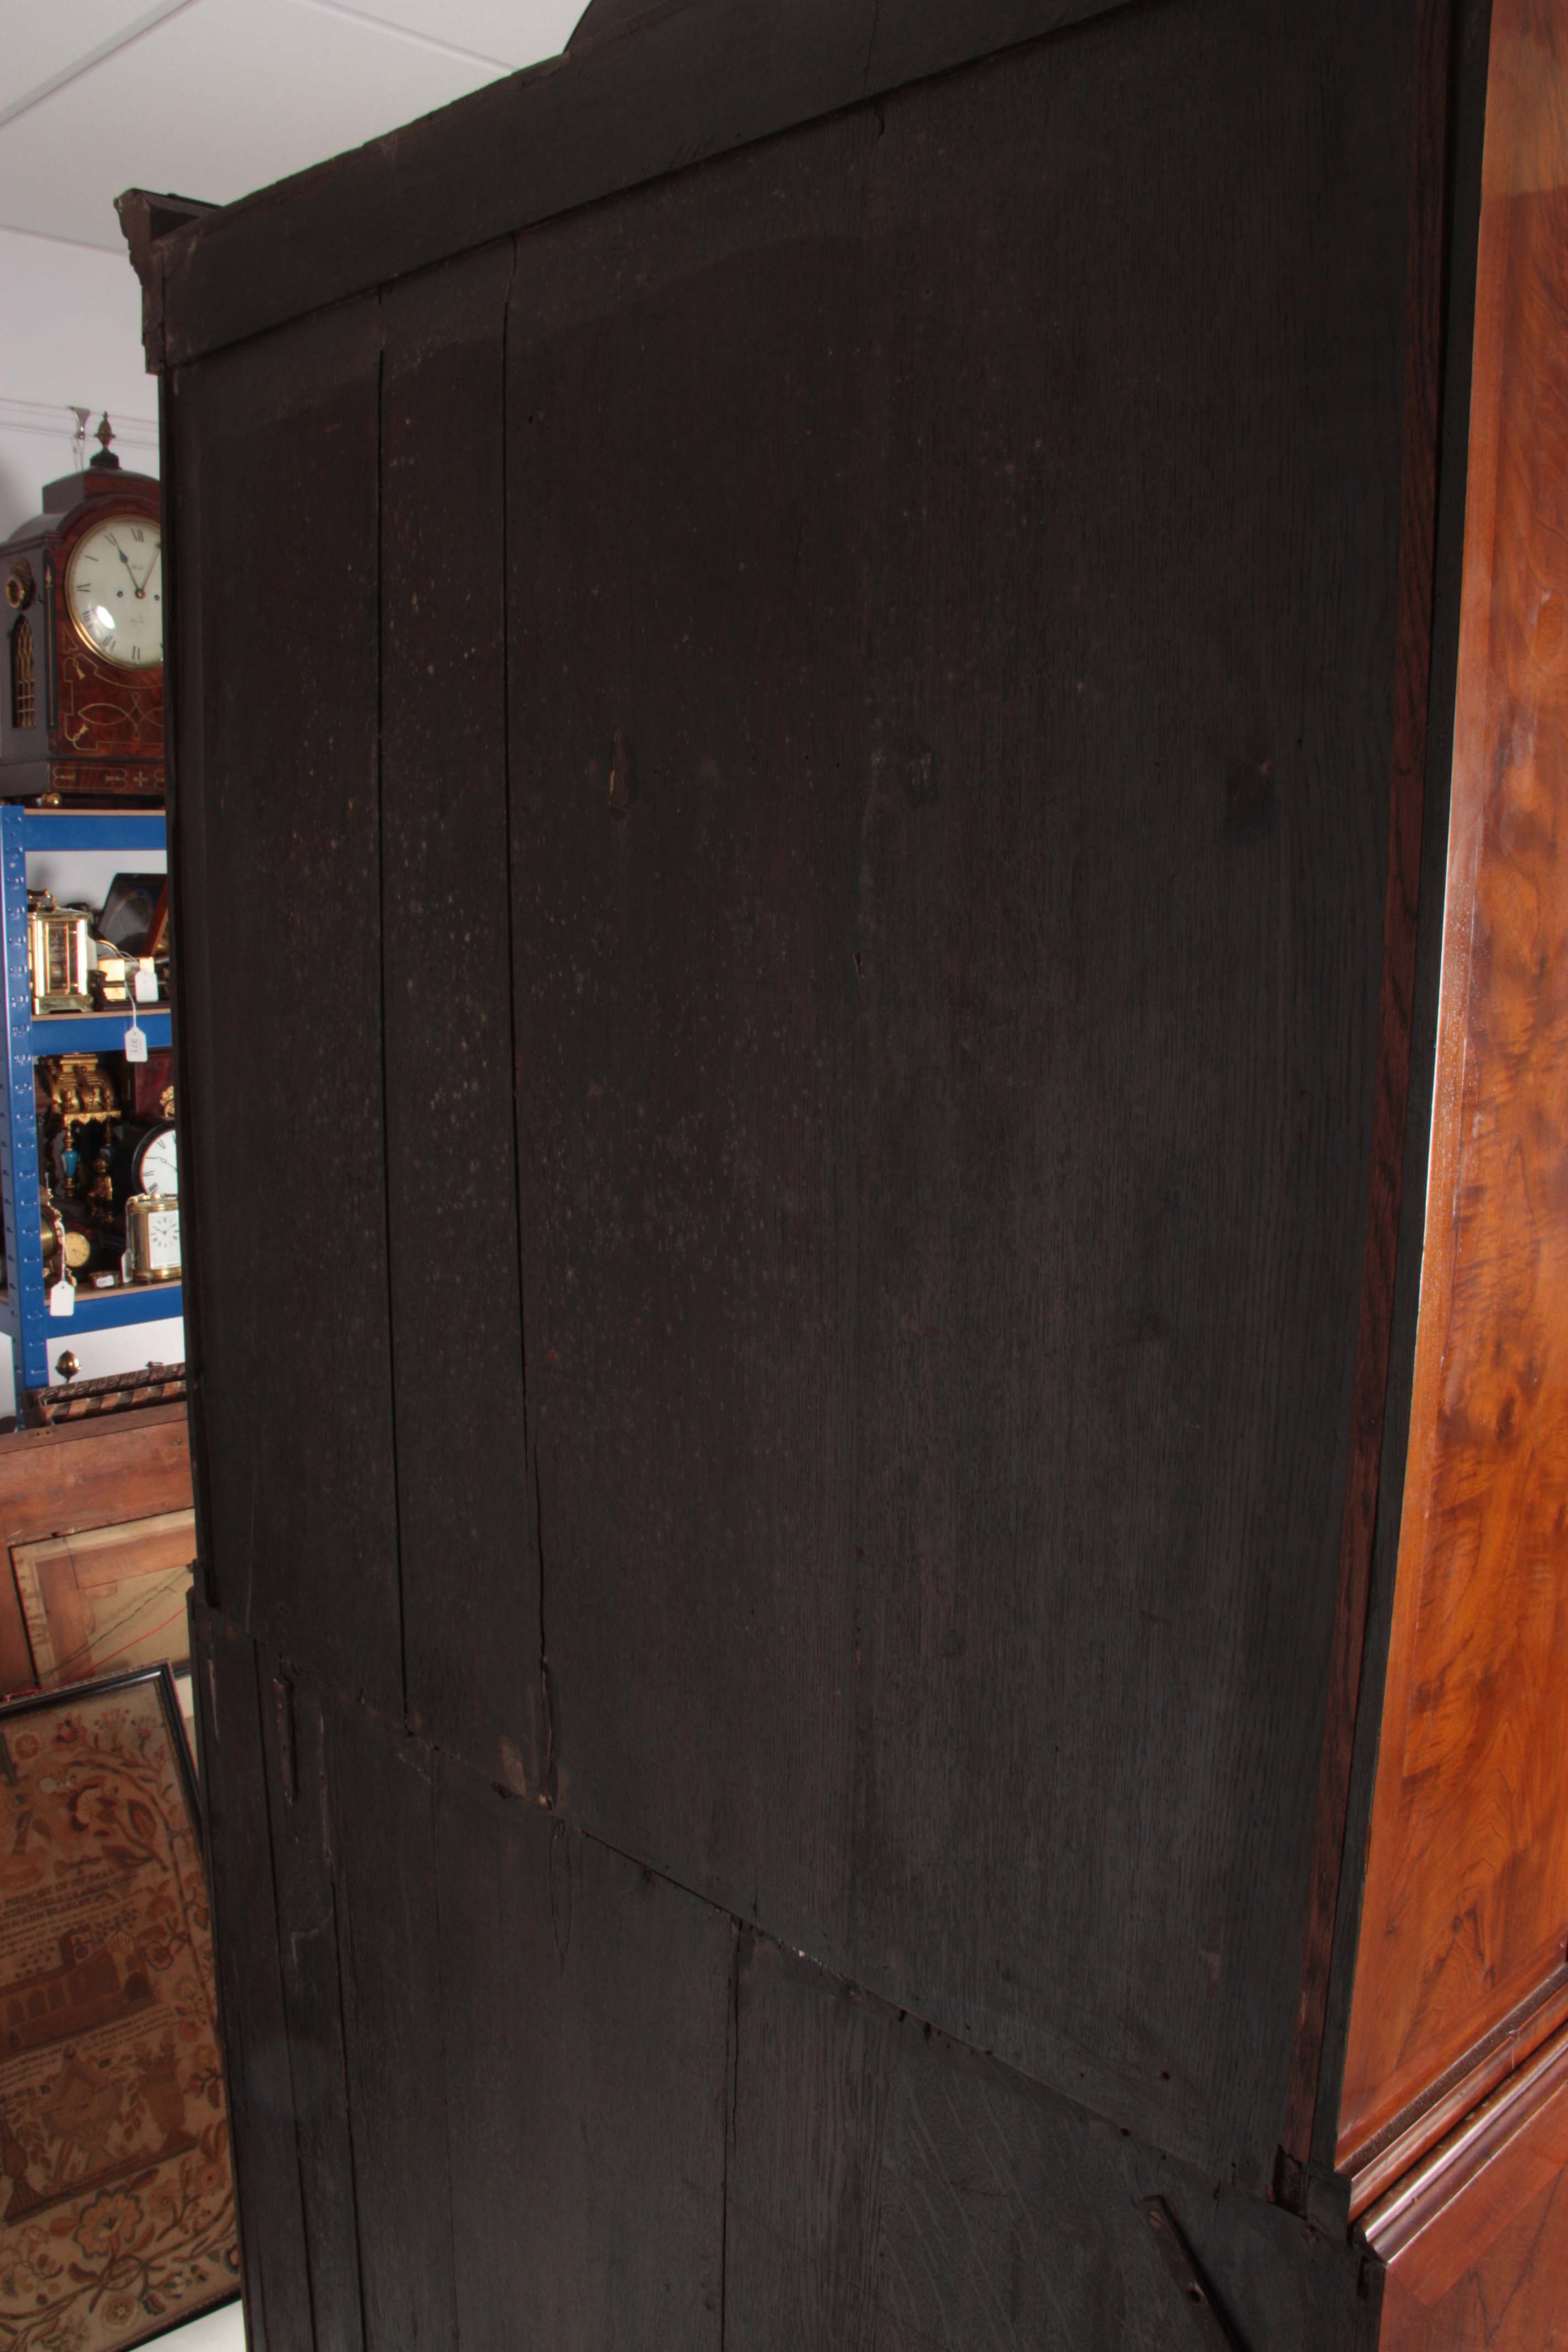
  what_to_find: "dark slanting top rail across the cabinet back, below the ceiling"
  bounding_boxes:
[127,0,1150,372]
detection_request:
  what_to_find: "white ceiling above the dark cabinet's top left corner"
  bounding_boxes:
[0,0,583,252]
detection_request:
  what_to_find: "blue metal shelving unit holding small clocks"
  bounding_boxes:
[0,804,183,1387]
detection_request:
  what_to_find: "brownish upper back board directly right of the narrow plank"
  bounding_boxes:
[508,115,877,2003]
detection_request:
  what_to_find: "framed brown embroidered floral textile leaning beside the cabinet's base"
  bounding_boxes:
[0,1675,237,2352]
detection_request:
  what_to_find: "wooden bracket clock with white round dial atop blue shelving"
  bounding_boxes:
[0,416,165,802]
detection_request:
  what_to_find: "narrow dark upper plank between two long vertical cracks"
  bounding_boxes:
[367,242,543,1792]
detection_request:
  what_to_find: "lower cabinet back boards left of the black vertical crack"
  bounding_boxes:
[200,1614,736,2352]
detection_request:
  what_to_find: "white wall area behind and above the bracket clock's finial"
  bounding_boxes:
[0,228,157,538]
